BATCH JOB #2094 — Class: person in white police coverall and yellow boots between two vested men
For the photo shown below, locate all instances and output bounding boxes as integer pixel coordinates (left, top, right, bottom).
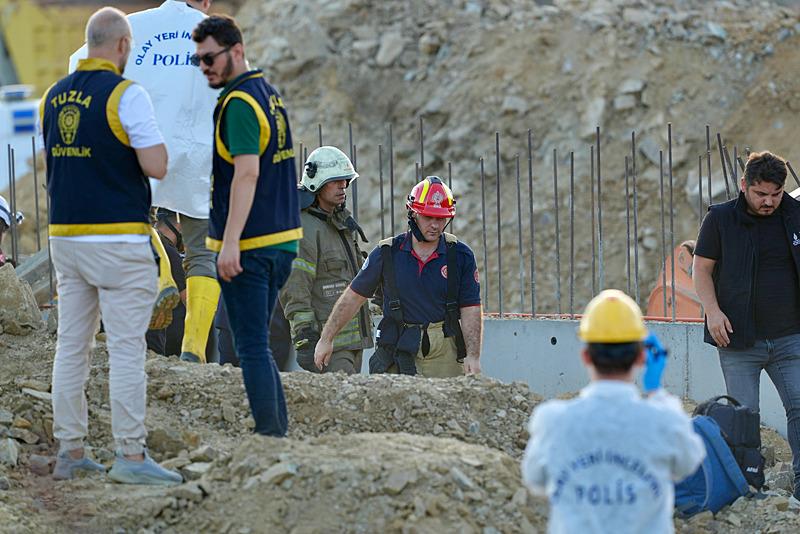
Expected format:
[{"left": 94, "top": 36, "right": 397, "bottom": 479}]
[{"left": 70, "top": 0, "right": 219, "bottom": 362}]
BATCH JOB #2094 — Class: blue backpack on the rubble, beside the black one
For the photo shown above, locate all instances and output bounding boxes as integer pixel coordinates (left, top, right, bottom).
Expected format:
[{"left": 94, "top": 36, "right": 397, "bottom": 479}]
[{"left": 675, "top": 415, "right": 750, "bottom": 518}]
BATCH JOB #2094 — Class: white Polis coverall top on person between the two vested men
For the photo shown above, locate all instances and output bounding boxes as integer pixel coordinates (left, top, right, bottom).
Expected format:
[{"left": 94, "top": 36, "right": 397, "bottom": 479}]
[{"left": 69, "top": 0, "right": 218, "bottom": 219}]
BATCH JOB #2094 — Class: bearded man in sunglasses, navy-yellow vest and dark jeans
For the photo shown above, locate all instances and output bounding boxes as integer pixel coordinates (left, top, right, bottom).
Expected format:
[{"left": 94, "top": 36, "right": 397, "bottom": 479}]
[{"left": 192, "top": 15, "right": 303, "bottom": 436}]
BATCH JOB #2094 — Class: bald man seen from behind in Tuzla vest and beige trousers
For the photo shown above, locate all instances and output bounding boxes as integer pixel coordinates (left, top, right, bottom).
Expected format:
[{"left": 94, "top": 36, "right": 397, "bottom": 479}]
[{"left": 40, "top": 7, "right": 182, "bottom": 485}]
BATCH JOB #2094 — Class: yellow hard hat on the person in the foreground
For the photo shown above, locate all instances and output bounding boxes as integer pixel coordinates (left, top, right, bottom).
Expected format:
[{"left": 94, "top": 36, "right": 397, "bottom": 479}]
[{"left": 578, "top": 289, "right": 647, "bottom": 343}]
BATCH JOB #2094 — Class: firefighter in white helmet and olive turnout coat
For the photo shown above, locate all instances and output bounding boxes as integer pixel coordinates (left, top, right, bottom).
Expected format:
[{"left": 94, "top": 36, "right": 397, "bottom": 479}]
[{"left": 280, "top": 146, "right": 372, "bottom": 374}]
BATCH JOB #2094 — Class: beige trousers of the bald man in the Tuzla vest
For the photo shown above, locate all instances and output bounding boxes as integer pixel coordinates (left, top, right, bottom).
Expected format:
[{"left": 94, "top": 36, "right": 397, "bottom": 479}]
[{"left": 50, "top": 239, "right": 157, "bottom": 455}]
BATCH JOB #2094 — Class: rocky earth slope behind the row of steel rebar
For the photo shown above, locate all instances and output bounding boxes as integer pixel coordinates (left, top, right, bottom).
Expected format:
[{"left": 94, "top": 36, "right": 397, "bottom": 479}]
[{"left": 228, "top": 0, "right": 800, "bottom": 312}]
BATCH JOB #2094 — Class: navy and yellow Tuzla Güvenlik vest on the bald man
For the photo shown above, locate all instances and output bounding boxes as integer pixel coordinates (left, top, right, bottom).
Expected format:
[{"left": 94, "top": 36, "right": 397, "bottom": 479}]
[{"left": 40, "top": 58, "right": 150, "bottom": 236}]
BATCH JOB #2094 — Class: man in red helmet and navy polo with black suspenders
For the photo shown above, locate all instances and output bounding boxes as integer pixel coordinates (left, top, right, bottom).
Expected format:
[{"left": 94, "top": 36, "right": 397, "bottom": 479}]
[{"left": 314, "top": 176, "right": 483, "bottom": 377}]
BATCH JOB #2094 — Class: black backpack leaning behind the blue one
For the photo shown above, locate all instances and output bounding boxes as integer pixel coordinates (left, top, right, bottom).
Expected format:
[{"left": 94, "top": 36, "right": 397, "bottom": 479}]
[{"left": 694, "top": 395, "right": 765, "bottom": 490}]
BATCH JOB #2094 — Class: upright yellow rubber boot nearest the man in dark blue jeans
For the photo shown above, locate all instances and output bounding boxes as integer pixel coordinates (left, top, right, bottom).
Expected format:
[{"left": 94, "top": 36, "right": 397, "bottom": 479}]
[{"left": 181, "top": 276, "right": 220, "bottom": 363}]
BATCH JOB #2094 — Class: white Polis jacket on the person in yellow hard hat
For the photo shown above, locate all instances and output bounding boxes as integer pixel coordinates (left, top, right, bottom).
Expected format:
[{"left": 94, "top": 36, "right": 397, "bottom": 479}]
[{"left": 522, "top": 380, "right": 705, "bottom": 534}]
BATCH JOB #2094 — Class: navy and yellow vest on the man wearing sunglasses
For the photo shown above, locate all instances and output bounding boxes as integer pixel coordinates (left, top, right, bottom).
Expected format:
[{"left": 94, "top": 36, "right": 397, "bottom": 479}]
[{"left": 206, "top": 70, "right": 303, "bottom": 252}]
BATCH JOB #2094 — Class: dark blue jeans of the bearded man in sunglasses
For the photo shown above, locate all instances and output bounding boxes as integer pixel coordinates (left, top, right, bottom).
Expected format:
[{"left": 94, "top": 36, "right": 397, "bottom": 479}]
[{"left": 220, "top": 248, "right": 295, "bottom": 436}]
